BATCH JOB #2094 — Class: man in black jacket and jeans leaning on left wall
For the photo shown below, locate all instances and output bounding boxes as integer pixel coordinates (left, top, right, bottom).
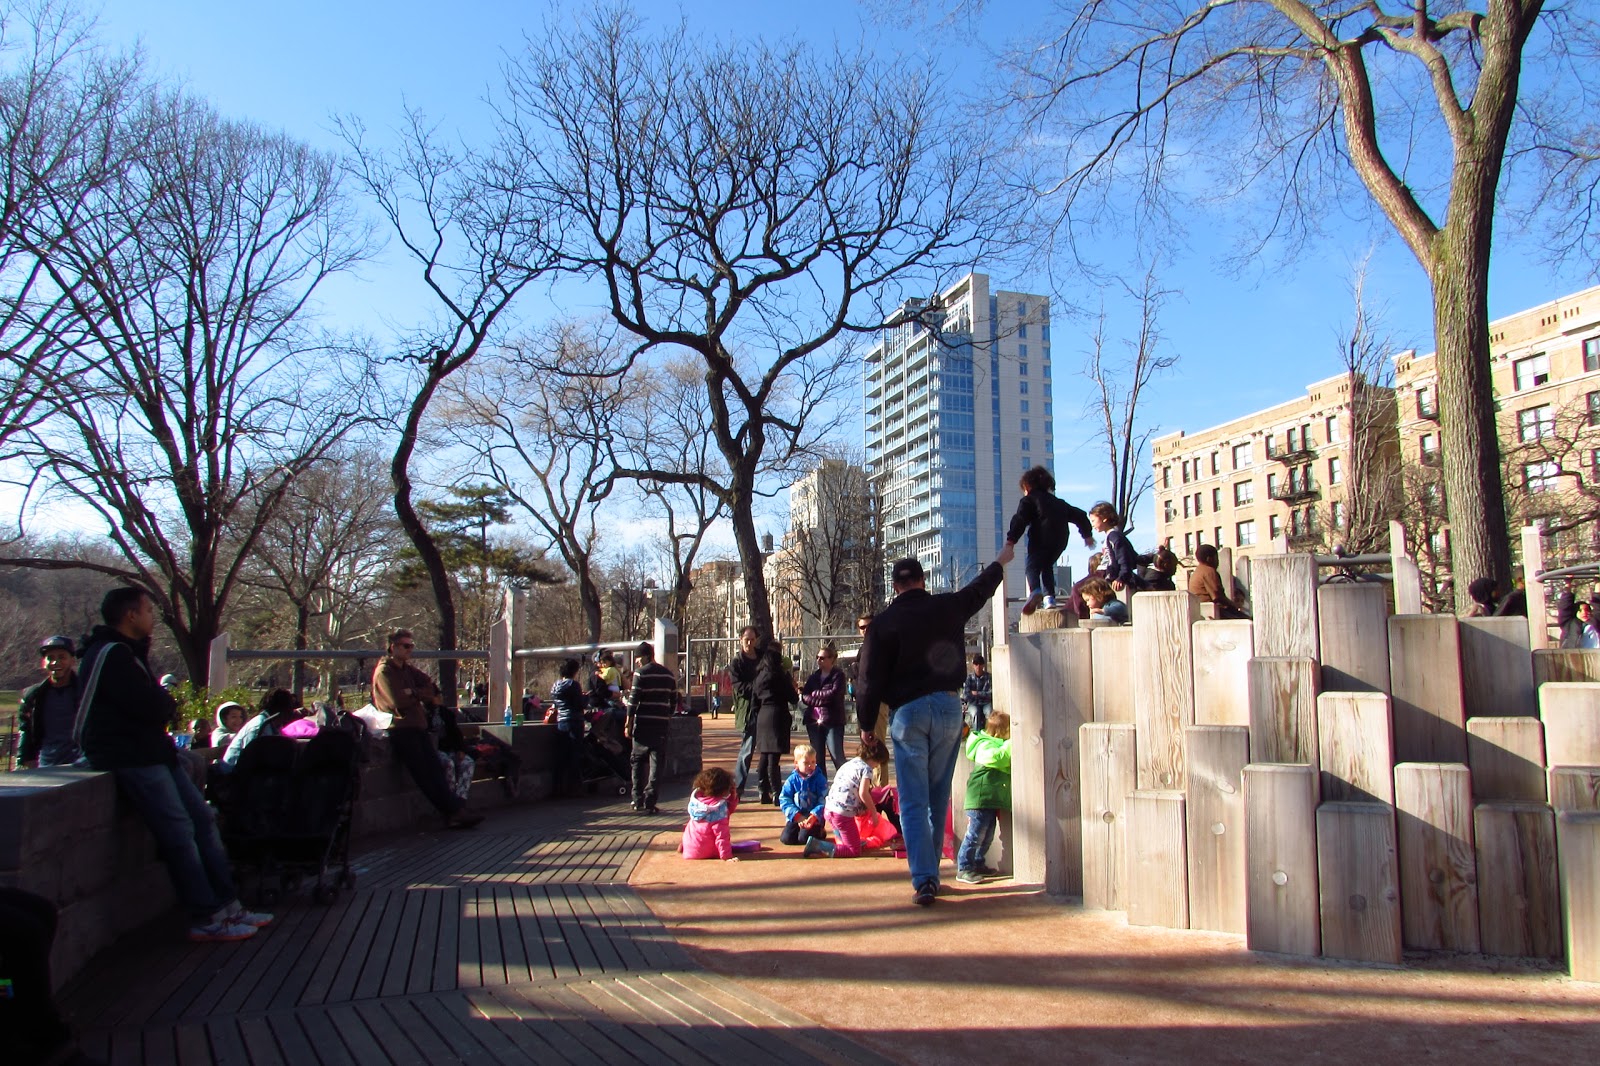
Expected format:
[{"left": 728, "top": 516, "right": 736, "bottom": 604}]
[{"left": 77, "top": 587, "right": 272, "bottom": 941}]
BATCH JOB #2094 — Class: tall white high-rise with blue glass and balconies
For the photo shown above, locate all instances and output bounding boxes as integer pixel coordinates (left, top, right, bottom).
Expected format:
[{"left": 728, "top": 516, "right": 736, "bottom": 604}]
[{"left": 866, "top": 274, "right": 1056, "bottom": 595}]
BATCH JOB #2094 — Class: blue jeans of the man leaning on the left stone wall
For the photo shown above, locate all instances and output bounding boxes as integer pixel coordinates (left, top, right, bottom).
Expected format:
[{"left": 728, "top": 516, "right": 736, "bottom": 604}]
[{"left": 112, "top": 763, "right": 238, "bottom": 920}]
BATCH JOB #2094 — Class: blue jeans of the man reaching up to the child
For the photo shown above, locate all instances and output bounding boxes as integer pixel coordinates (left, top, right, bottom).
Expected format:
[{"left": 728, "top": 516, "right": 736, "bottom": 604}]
[{"left": 890, "top": 691, "right": 962, "bottom": 888}]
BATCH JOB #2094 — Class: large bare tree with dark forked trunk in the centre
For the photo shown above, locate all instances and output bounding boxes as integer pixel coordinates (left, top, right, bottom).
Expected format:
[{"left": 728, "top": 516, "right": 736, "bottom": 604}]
[{"left": 502, "top": 11, "right": 1011, "bottom": 629}]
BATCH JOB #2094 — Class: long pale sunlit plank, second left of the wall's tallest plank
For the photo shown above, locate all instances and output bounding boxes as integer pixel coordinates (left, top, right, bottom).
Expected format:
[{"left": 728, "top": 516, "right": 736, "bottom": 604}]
[{"left": 1133, "top": 592, "right": 1200, "bottom": 789}]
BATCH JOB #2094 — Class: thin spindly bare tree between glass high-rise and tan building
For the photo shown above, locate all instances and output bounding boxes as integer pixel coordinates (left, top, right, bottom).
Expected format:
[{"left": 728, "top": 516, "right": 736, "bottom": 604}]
[{"left": 1083, "top": 262, "right": 1178, "bottom": 530}]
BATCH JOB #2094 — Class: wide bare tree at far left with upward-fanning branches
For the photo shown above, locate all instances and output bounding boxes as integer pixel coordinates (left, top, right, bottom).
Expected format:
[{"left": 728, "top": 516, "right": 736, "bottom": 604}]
[{"left": 3, "top": 90, "right": 366, "bottom": 683}]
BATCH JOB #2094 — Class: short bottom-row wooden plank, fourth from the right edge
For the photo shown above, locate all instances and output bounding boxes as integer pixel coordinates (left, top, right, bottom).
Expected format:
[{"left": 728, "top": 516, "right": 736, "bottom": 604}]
[{"left": 1317, "top": 802, "right": 1403, "bottom": 965}]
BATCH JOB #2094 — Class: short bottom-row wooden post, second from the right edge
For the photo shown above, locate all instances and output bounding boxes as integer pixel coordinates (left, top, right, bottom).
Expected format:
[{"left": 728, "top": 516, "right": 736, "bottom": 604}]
[{"left": 1474, "top": 802, "right": 1562, "bottom": 959}]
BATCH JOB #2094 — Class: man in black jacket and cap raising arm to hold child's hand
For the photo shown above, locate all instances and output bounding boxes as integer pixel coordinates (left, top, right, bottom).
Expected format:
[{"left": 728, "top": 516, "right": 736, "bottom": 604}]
[{"left": 856, "top": 543, "right": 1014, "bottom": 906}]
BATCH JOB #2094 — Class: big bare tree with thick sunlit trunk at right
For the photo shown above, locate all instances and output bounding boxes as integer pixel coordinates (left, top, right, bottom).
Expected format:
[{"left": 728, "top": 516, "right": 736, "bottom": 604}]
[{"left": 1011, "top": 0, "right": 1592, "bottom": 607}]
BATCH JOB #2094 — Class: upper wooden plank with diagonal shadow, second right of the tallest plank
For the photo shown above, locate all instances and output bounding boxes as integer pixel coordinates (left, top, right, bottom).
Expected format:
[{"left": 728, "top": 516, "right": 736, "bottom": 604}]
[{"left": 1389, "top": 615, "right": 1467, "bottom": 762}]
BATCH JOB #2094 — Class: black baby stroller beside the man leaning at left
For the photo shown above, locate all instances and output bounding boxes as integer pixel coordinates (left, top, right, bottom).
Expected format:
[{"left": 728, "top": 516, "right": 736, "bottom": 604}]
[{"left": 213, "top": 728, "right": 360, "bottom": 906}]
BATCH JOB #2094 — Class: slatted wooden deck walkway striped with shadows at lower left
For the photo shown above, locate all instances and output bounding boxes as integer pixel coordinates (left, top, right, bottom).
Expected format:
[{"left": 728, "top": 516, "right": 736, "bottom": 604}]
[{"left": 62, "top": 800, "right": 883, "bottom": 1066}]
